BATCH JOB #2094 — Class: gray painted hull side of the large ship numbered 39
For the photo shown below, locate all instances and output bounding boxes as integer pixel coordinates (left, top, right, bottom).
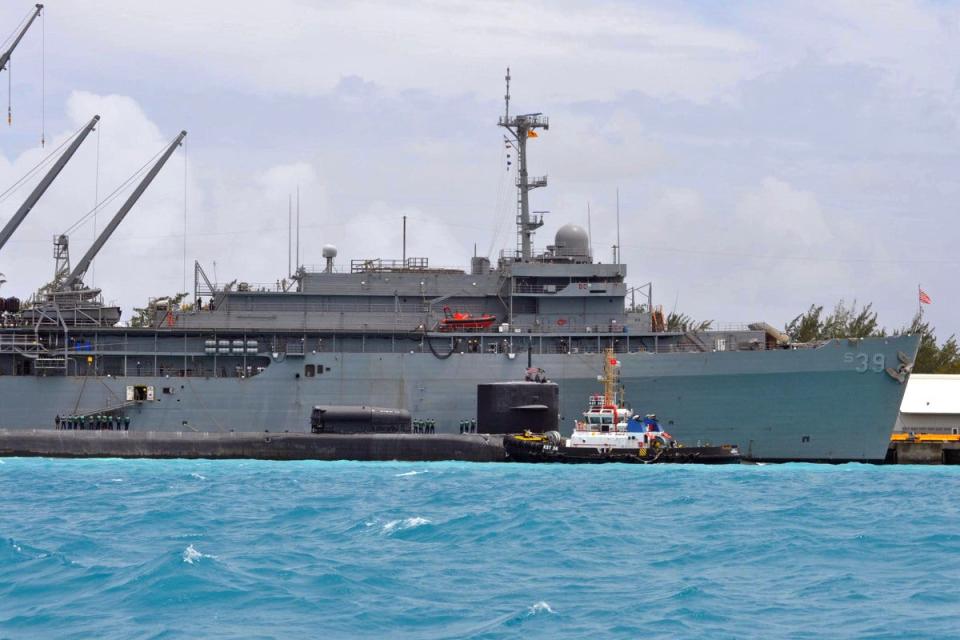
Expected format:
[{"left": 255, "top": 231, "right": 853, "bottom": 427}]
[{"left": 0, "top": 336, "right": 918, "bottom": 462}]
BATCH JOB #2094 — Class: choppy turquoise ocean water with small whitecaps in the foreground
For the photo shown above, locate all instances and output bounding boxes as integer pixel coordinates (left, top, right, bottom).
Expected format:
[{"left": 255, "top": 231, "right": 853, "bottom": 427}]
[{"left": 0, "top": 458, "right": 960, "bottom": 638}]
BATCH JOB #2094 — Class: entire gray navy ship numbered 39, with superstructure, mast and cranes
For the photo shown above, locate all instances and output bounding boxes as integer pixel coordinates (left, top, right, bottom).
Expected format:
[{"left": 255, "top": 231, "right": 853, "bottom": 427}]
[{"left": 0, "top": 71, "right": 919, "bottom": 462}]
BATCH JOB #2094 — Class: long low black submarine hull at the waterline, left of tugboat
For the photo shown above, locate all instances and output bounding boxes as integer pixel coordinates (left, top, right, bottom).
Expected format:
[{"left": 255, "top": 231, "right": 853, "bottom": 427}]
[{"left": 0, "top": 429, "right": 505, "bottom": 462}]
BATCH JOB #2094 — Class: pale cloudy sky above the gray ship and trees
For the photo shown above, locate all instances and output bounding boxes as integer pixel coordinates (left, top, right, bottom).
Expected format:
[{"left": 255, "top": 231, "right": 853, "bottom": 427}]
[{"left": 0, "top": 0, "right": 960, "bottom": 340}]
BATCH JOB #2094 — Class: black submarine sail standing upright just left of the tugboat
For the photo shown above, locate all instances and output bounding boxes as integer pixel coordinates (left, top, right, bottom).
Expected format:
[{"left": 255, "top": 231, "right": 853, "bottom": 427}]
[{"left": 477, "top": 382, "right": 560, "bottom": 433}]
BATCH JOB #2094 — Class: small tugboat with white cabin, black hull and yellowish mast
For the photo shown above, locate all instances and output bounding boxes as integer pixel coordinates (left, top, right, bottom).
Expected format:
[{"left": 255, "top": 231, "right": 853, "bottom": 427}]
[{"left": 503, "top": 349, "right": 740, "bottom": 464}]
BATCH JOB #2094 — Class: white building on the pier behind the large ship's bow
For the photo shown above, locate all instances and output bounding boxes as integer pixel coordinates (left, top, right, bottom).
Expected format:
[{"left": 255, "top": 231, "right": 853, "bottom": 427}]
[{"left": 894, "top": 373, "right": 960, "bottom": 435}]
